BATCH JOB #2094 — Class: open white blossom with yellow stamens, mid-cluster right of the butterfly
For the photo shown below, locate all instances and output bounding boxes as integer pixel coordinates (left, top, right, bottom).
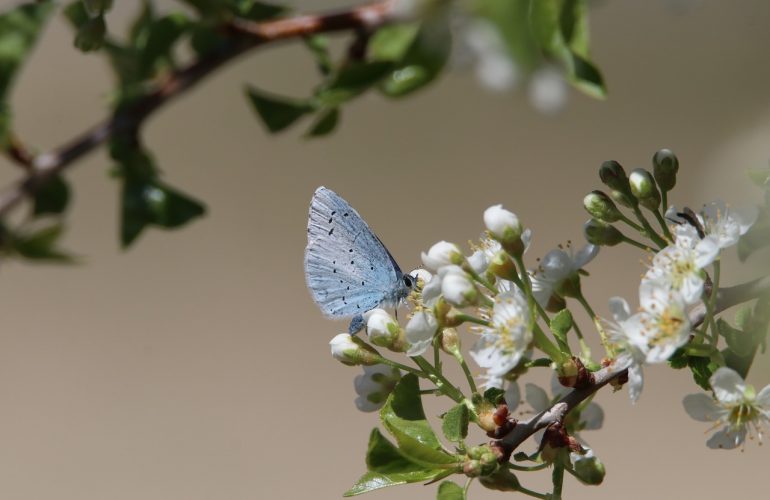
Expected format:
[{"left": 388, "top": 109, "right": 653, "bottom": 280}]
[{"left": 470, "top": 288, "right": 532, "bottom": 377}]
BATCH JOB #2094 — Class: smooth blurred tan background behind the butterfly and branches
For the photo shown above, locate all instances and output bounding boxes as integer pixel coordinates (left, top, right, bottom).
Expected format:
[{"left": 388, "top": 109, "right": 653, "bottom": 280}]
[{"left": 0, "top": 0, "right": 770, "bottom": 500}]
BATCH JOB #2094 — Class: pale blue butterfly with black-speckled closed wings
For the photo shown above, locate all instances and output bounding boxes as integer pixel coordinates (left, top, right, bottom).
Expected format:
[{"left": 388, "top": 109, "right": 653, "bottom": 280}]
[{"left": 305, "top": 186, "right": 416, "bottom": 334}]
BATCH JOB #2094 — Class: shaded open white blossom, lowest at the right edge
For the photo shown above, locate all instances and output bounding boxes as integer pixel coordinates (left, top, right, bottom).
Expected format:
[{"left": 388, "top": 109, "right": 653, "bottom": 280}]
[{"left": 683, "top": 367, "right": 770, "bottom": 449}]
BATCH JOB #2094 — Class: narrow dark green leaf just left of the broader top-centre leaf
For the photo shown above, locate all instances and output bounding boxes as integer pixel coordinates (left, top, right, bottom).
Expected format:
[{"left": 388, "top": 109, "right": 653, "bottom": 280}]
[{"left": 316, "top": 61, "right": 393, "bottom": 107}]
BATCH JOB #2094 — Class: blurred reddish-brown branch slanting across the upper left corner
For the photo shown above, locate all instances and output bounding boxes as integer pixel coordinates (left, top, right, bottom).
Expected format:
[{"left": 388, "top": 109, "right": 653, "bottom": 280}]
[{"left": 0, "top": 0, "right": 400, "bottom": 216}]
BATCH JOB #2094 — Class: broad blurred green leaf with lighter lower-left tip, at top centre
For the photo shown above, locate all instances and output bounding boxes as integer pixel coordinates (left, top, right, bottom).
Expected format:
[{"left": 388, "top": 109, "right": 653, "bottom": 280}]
[{"left": 380, "top": 8, "right": 452, "bottom": 97}]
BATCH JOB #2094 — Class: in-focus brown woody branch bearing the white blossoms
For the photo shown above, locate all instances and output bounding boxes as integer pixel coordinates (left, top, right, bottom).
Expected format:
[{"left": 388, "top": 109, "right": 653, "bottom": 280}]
[{"left": 496, "top": 276, "right": 770, "bottom": 457}]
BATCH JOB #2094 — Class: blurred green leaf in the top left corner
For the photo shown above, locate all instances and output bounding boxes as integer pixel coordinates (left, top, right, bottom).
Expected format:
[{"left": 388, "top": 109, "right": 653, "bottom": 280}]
[{"left": 0, "top": 1, "right": 54, "bottom": 149}]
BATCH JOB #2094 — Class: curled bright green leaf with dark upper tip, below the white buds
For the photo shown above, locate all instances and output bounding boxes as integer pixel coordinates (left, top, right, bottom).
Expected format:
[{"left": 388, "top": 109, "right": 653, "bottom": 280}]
[{"left": 380, "top": 374, "right": 457, "bottom": 468}]
